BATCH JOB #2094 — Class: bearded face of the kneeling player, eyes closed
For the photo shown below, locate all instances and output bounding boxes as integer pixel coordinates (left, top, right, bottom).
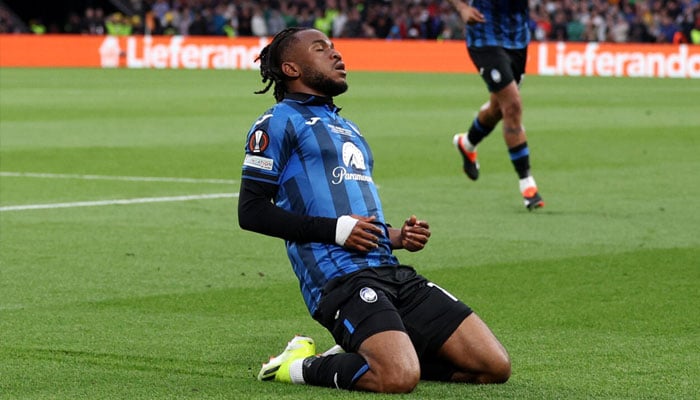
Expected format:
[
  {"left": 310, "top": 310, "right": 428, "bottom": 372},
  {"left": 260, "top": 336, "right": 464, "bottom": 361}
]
[{"left": 297, "top": 30, "right": 348, "bottom": 97}]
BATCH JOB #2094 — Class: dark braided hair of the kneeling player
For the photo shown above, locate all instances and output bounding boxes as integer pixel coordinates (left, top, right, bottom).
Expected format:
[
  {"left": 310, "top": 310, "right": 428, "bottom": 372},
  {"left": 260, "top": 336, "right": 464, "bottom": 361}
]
[{"left": 255, "top": 26, "right": 310, "bottom": 102}]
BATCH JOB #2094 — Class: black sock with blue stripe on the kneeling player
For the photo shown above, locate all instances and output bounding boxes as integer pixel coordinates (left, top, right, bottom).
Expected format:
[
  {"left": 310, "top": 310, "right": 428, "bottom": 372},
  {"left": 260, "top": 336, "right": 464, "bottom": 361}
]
[{"left": 302, "top": 353, "right": 369, "bottom": 389}]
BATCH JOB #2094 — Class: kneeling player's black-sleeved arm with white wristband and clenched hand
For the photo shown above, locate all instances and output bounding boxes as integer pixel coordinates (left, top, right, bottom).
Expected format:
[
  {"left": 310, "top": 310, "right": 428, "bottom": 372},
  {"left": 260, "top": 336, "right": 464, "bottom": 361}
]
[{"left": 238, "top": 178, "right": 382, "bottom": 252}]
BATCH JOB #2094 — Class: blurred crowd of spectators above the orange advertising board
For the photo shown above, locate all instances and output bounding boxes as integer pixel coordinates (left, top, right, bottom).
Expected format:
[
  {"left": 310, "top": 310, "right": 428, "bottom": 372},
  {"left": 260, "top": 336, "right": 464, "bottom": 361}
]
[{"left": 0, "top": 0, "right": 700, "bottom": 44}]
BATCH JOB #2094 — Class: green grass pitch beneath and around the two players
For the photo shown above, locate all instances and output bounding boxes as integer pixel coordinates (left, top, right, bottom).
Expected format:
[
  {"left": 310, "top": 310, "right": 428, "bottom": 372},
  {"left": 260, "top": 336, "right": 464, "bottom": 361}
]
[{"left": 0, "top": 69, "right": 700, "bottom": 399}]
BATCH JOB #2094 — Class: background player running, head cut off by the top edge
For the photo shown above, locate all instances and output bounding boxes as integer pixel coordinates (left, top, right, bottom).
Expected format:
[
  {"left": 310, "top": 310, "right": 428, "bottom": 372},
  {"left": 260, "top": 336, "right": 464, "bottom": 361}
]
[{"left": 448, "top": 0, "right": 544, "bottom": 210}]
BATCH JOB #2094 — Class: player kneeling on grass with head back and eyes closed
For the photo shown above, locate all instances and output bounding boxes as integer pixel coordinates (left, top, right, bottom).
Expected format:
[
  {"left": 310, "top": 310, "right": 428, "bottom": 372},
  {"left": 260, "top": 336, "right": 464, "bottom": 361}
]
[{"left": 238, "top": 28, "right": 511, "bottom": 393}]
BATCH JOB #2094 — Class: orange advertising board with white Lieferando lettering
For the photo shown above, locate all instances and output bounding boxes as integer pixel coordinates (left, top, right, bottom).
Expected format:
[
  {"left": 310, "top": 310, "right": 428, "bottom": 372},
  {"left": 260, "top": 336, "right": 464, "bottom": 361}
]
[{"left": 0, "top": 35, "right": 700, "bottom": 78}]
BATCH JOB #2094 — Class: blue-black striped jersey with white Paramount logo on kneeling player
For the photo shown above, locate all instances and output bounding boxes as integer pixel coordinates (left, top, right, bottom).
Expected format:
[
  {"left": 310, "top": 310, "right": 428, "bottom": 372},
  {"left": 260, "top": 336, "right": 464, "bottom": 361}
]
[{"left": 242, "top": 96, "right": 398, "bottom": 315}]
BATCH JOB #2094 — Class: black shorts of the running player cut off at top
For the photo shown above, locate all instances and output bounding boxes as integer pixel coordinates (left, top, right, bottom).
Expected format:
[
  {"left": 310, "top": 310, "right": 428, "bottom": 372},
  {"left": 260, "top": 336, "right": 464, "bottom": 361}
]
[{"left": 467, "top": 47, "right": 527, "bottom": 93}]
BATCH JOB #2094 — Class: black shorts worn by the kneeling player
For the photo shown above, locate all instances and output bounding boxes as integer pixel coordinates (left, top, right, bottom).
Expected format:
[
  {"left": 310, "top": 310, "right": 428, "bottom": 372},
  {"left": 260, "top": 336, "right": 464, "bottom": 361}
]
[{"left": 314, "top": 266, "right": 472, "bottom": 358}]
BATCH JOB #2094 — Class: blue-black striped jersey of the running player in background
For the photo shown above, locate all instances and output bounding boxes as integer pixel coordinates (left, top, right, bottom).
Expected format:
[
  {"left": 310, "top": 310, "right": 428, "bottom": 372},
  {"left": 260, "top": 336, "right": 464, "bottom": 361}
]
[{"left": 467, "top": 0, "right": 530, "bottom": 49}]
